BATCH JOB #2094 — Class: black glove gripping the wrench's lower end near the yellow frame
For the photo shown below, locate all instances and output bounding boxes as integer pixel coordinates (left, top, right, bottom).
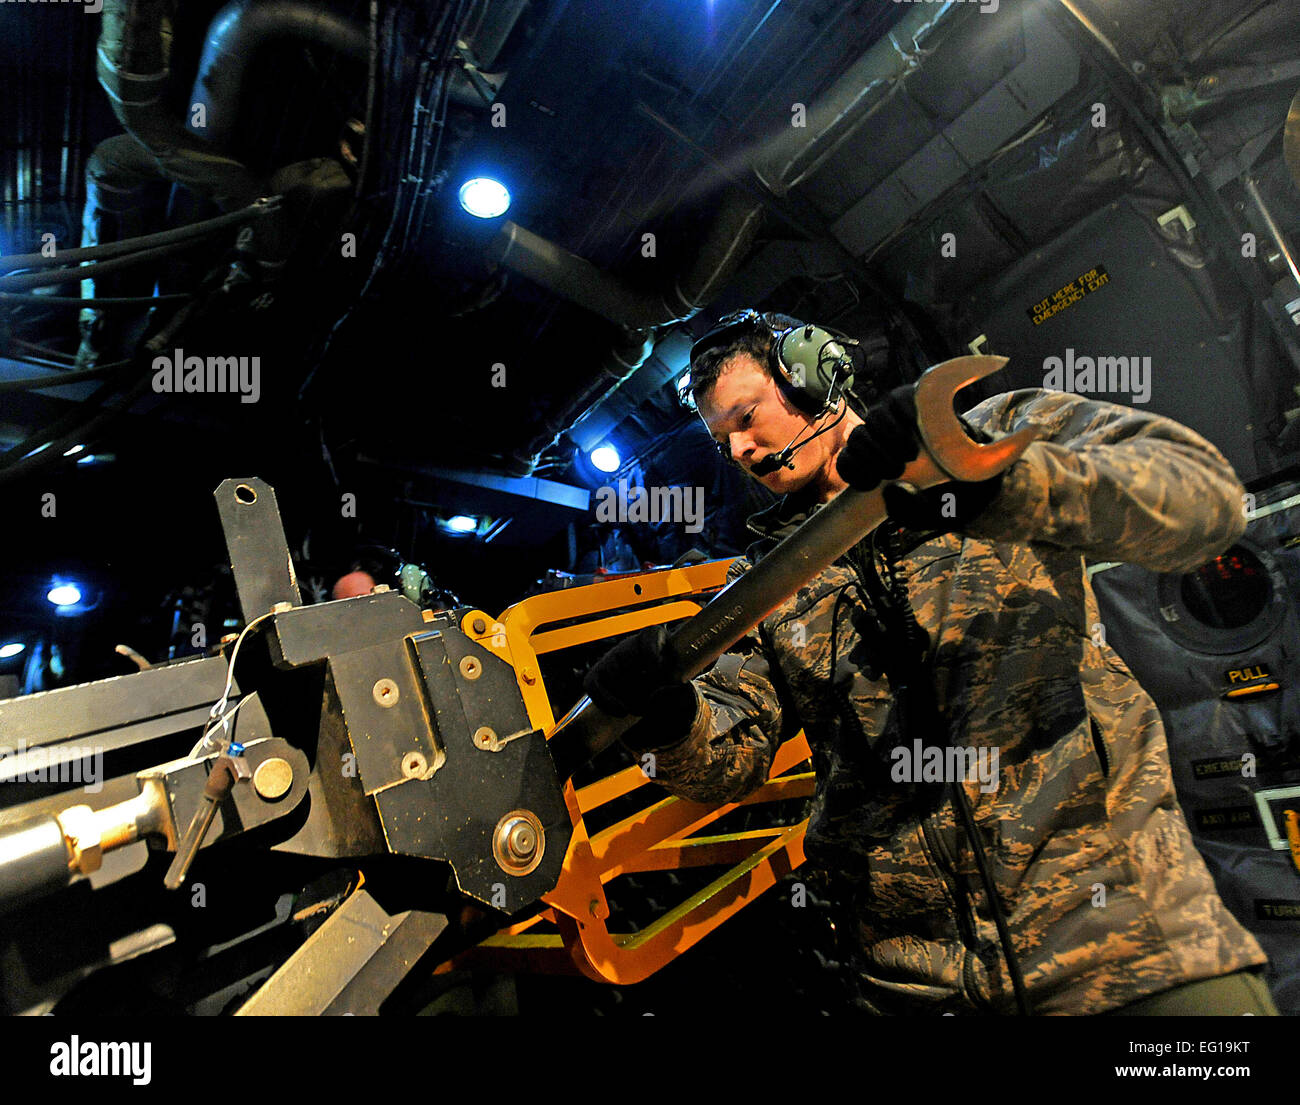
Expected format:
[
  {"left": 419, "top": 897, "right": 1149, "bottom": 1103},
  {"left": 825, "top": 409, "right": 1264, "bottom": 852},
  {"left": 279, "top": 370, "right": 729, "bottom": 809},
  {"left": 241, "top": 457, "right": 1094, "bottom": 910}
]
[{"left": 582, "top": 625, "right": 697, "bottom": 751}]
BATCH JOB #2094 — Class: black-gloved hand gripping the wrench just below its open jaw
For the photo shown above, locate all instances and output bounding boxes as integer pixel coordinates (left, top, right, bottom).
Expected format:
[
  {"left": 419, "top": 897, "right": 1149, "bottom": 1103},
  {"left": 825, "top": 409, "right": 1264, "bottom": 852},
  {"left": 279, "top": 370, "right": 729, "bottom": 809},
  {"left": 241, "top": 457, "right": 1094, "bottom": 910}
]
[{"left": 836, "top": 385, "right": 1005, "bottom": 533}]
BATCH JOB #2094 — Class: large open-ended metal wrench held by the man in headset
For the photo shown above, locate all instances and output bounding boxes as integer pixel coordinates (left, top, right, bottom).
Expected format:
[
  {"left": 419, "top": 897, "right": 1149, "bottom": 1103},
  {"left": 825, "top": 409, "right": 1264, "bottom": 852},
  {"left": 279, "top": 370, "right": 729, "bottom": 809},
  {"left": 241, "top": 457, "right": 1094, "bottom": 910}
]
[{"left": 546, "top": 356, "right": 1043, "bottom": 779}]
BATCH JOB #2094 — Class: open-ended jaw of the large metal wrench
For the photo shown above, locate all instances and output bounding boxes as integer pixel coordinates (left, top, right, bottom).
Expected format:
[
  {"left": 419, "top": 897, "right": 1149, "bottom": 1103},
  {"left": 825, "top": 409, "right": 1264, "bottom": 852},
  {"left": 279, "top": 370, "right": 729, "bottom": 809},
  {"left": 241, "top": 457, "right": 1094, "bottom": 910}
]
[{"left": 915, "top": 354, "right": 1043, "bottom": 482}]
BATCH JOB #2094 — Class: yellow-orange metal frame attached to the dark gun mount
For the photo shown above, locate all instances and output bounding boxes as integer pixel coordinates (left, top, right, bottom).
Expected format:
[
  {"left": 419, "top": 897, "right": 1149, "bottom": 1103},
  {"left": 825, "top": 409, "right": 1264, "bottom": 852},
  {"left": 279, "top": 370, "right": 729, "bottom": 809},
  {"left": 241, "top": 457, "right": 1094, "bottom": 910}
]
[{"left": 445, "top": 560, "right": 814, "bottom": 984}]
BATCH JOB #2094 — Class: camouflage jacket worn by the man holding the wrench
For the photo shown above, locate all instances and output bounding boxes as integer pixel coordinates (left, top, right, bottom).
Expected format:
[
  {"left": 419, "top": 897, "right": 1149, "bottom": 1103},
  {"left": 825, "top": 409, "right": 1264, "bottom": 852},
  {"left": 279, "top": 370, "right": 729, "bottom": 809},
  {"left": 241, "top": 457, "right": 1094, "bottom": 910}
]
[{"left": 657, "top": 389, "right": 1265, "bottom": 1014}]
